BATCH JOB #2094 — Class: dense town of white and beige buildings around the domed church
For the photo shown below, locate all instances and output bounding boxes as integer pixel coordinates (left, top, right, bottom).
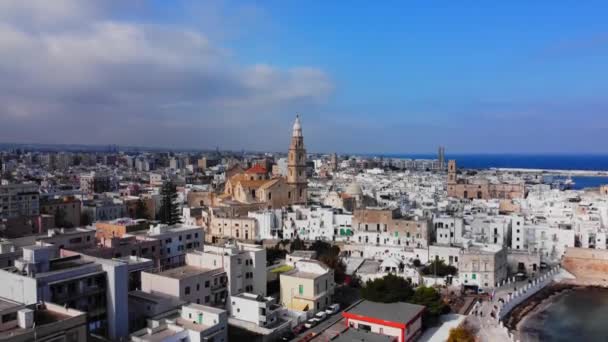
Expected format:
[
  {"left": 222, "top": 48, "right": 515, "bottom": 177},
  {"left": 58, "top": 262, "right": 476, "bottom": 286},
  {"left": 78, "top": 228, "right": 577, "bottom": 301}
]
[{"left": 0, "top": 117, "right": 608, "bottom": 342}]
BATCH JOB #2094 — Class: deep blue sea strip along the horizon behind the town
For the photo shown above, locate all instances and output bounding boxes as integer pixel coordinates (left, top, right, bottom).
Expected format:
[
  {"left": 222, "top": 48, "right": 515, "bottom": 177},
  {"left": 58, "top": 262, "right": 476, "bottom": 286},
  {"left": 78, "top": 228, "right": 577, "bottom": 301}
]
[{"left": 379, "top": 154, "right": 608, "bottom": 190}]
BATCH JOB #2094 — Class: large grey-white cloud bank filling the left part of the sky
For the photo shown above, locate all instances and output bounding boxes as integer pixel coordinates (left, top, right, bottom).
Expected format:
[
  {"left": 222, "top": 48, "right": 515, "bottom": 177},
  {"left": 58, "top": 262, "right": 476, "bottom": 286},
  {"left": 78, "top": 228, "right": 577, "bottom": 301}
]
[{"left": 0, "top": 0, "right": 333, "bottom": 148}]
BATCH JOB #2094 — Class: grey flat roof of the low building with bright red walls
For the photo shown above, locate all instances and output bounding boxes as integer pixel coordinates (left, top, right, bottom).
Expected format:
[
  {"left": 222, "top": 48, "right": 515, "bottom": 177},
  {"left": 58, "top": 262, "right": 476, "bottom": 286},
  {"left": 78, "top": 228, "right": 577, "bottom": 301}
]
[{"left": 345, "top": 300, "right": 424, "bottom": 324}]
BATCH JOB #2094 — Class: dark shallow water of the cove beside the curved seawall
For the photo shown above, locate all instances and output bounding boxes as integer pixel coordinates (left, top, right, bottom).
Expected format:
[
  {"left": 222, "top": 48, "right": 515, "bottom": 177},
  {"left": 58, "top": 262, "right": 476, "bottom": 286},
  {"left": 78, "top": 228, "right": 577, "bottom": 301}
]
[{"left": 520, "top": 288, "right": 608, "bottom": 342}]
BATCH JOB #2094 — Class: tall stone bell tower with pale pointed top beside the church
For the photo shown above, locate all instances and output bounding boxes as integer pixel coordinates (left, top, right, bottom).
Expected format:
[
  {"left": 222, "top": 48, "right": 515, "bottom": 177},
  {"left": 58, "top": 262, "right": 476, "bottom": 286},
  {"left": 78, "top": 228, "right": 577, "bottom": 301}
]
[{"left": 287, "top": 114, "right": 308, "bottom": 204}]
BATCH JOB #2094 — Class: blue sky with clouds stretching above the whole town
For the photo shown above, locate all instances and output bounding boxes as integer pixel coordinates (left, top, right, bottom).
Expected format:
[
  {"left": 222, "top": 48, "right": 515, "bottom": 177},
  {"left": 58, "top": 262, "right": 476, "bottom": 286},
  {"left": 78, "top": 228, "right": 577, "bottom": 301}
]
[{"left": 0, "top": 0, "right": 608, "bottom": 153}]
